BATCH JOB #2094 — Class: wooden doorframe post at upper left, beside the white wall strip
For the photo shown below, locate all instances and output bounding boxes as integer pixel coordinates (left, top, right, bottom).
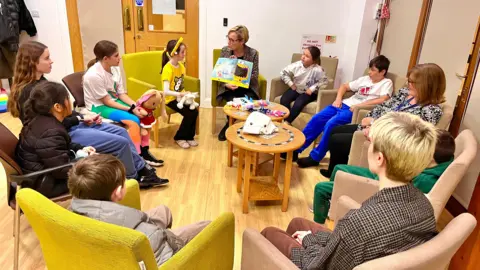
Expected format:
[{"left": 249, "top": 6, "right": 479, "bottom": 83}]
[{"left": 65, "top": 0, "right": 85, "bottom": 72}]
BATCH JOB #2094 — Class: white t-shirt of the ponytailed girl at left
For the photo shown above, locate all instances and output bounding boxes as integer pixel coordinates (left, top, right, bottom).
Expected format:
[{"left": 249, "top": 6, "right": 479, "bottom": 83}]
[{"left": 83, "top": 62, "right": 126, "bottom": 110}]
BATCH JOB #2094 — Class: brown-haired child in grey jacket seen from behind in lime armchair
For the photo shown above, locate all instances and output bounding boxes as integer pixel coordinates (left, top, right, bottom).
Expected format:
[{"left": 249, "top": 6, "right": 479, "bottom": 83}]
[{"left": 68, "top": 154, "right": 210, "bottom": 266}]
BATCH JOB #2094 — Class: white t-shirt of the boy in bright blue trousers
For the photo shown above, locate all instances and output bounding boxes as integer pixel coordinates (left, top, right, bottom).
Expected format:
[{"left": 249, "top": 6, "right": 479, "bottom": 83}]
[{"left": 342, "top": 76, "right": 393, "bottom": 107}]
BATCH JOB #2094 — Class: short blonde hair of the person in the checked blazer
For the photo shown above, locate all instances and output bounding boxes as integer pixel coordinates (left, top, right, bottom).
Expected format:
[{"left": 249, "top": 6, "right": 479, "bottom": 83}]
[{"left": 369, "top": 112, "right": 437, "bottom": 182}]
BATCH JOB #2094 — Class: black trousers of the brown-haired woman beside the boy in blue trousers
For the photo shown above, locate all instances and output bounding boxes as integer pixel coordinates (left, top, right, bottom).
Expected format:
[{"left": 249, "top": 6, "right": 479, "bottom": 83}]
[{"left": 328, "top": 124, "right": 358, "bottom": 174}]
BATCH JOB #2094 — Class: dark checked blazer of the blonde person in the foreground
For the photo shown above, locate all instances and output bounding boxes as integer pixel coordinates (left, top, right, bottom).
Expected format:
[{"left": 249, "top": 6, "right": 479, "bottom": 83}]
[{"left": 291, "top": 184, "right": 437, "bottom": 270}]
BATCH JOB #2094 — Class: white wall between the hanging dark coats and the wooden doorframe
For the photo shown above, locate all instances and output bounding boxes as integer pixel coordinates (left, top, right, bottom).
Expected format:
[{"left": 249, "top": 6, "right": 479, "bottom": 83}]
[{"left": 21, "top": 0, "right": 73, "bottom": 82}]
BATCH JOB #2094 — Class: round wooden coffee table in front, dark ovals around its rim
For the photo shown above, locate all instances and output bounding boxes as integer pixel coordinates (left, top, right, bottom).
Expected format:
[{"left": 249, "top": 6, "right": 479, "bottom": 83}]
[{"left": 226, "top": 122, "right": 305, "bottom": 213}]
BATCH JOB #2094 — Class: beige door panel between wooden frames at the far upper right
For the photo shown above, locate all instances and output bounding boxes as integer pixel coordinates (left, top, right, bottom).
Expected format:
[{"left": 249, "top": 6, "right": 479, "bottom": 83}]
[{"left": 419, "top": 0, "right": 480, "bottom": 106}]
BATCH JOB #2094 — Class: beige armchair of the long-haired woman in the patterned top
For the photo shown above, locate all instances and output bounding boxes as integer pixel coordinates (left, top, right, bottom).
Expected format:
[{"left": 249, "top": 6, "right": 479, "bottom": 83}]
[{"left": 348, "top": 103, "right": 453, "bottom": 167}]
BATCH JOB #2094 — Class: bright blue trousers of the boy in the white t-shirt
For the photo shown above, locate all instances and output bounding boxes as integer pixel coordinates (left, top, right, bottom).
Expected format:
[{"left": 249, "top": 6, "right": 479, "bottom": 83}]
[{"left": 297, "top": 103, "right": 353, "bottom": 162}]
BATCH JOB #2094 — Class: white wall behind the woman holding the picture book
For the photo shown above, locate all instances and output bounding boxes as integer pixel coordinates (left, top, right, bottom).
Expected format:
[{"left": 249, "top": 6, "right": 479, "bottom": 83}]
[{"left": 199, "top": 0, "right": 379, "bottom": 107}]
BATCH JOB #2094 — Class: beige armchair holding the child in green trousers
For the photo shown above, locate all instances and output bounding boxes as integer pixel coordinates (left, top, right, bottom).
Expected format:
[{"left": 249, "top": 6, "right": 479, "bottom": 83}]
[{"left": 329, "top": 129, "right": 477, "bottom": 220}]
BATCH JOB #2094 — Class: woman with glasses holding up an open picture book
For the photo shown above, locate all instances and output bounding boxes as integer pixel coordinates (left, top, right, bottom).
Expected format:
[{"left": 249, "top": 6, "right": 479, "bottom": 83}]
[{"left": 216, "top": 25, "right": 259, "bottom": 141}]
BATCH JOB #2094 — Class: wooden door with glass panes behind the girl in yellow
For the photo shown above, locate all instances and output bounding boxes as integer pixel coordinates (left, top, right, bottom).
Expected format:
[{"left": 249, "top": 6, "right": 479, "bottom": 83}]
[{"left": 122, "top": 0, "right": 199, "bottom": 78}]
